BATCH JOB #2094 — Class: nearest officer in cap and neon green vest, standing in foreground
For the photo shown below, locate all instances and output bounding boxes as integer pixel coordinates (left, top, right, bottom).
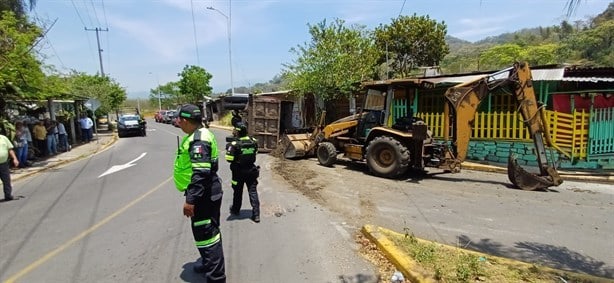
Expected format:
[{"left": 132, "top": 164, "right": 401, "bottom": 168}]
[{"left": 173, "top": 104, "right": 226, "bottom": 282}]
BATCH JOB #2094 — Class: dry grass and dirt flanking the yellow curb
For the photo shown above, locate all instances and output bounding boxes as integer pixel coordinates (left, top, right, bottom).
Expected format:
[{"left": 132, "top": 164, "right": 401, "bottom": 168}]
[{"left": 358, "top": 229, "right": 614, "bottom": 283}]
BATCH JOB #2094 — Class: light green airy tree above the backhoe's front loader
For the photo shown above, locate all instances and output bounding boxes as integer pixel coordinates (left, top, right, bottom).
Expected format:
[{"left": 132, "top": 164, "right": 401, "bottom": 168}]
[{"left": 283, "top": 19, "right": 378, "bottom": 101}]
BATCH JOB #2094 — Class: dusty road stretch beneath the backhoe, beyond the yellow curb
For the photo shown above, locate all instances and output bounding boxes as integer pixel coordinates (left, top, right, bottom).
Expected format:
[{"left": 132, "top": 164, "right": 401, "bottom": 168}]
[{"left": 276, "top": 154, "right": 614, "bottom": 278}]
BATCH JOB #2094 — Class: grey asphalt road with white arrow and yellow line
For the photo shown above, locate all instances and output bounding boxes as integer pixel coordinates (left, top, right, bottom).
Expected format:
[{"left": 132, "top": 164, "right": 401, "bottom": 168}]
[{"left": 0, "top": 122, "right": 377, "bottom": 282}]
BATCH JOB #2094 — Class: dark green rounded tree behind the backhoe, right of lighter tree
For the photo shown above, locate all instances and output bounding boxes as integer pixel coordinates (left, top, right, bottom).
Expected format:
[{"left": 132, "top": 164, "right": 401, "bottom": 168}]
[{"left": 375, "top": 14, "right": 450, "bottom": 77}]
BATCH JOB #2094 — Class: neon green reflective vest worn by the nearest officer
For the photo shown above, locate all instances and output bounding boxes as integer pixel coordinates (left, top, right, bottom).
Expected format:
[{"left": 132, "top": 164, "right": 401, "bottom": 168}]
[{"left": 173, "top": 128, "right": 218, "bottom": 192}]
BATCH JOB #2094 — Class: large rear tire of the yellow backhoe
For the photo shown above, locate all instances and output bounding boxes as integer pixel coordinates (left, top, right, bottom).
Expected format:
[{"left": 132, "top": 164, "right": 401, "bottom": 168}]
[{"left": 367, "top": 136, "right": 409, "bottom": 178}]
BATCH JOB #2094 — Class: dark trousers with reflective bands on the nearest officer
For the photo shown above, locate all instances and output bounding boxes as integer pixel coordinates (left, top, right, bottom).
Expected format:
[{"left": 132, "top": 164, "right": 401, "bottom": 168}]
[{"left": 190, "top": 195, "right": 226, "bottom": 283}]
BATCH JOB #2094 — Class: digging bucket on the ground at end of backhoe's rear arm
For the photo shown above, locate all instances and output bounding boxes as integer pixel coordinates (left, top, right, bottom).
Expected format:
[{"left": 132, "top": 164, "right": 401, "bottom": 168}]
[{"left": 507, "top": 154, "right": 563, "bottom": 191}]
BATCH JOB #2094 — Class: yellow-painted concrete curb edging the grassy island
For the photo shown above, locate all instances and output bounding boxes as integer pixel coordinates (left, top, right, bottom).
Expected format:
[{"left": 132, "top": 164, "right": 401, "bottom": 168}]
[{"left": 361, "top": 224, "right": 614, "bottom": 283}]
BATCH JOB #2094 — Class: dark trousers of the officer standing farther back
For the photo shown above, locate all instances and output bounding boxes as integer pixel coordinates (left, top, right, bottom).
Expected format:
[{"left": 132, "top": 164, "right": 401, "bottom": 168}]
[{"left": 230, "top": 166, "right": 260, "bottom": 216}]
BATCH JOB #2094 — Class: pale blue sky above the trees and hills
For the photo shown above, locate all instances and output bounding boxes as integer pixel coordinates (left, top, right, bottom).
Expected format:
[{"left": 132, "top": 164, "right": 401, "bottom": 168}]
[{"left": 31, "top": 0, "right": 611, "bottom": 98}]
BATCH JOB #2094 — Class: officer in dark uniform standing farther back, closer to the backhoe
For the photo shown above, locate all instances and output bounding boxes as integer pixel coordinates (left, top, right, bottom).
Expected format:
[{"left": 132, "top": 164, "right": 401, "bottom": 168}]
[{"left": 226, "top": 122, "right": 260, "bottom": 223}]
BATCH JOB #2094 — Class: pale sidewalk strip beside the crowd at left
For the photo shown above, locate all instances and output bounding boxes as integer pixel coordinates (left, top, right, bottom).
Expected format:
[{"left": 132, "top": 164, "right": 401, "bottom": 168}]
[{"left": 11, "top": 131, "right": 117, "bottom": 182}]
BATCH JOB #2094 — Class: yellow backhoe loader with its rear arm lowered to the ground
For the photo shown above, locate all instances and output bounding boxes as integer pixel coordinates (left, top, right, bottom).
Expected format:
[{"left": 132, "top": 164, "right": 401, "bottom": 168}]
[{"left": 282, "top": 63, "right": 562, "bottom": 190}]
